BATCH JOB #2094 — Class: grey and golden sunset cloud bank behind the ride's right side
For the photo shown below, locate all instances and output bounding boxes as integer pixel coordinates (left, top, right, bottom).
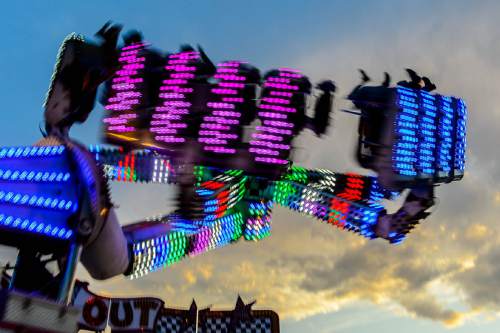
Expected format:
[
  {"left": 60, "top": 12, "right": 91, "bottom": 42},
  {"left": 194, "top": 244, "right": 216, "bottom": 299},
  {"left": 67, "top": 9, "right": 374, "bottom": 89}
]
[{"left": 76, "top": 2, "right": 500, "bottom": 326}]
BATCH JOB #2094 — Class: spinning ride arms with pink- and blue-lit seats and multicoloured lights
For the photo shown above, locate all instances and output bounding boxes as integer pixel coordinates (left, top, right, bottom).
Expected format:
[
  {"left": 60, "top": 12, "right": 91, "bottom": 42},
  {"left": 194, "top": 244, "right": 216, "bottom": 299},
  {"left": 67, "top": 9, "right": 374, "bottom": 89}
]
[{"left": 0, "top": 25, "right": 466, "bottom": 279}]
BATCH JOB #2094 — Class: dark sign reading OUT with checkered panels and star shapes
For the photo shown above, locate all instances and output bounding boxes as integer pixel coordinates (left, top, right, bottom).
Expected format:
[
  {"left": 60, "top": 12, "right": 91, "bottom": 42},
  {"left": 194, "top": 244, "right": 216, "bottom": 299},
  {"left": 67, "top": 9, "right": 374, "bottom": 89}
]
[{"left": 73, "top": 282, "right": 279, "bottom": 333}]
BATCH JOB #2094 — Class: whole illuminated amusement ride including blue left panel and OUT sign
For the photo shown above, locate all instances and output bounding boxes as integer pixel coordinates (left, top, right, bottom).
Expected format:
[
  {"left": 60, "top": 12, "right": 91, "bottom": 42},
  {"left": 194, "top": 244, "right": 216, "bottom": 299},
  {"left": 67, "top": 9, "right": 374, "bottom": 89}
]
[{"left": 0, "top": 24, "right": 467, "bottom": 332}]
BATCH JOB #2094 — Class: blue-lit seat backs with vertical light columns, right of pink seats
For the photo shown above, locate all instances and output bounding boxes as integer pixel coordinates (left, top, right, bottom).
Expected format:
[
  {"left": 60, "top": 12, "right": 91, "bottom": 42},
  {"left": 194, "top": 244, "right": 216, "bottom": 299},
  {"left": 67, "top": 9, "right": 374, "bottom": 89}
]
[{"left": 392, "top": 86, "right": 466, "bottom": 182}]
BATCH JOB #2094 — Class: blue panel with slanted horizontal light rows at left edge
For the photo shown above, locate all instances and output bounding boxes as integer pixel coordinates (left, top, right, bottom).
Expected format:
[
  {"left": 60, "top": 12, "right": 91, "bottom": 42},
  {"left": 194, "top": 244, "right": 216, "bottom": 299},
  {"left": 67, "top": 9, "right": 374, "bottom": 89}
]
[{"left": 0, "top": 146, "right": 78, "bottom": 241}]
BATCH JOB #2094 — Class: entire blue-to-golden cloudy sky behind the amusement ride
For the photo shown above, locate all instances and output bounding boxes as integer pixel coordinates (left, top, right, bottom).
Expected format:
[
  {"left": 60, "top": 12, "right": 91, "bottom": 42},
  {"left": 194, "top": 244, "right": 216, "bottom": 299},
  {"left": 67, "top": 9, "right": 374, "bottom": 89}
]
[{"left": 0, "top": 0, "right": 500, "bottom": 333}]
